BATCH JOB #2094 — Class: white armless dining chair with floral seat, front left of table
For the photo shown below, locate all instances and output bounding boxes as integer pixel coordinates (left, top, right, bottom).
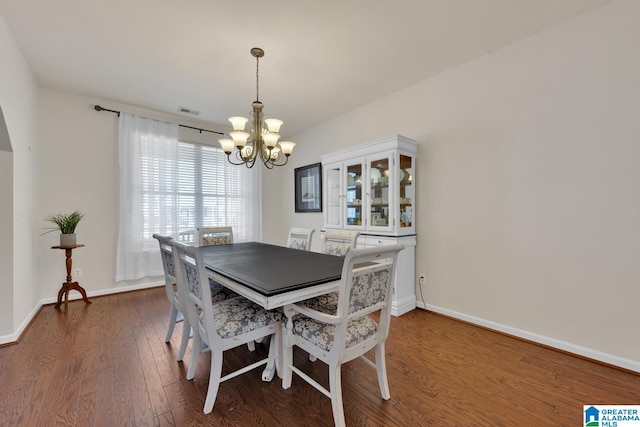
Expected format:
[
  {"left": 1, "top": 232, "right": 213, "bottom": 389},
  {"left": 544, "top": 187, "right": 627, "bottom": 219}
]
[{"left": 173, "top": 242, "right": 282, "bottom": 414}]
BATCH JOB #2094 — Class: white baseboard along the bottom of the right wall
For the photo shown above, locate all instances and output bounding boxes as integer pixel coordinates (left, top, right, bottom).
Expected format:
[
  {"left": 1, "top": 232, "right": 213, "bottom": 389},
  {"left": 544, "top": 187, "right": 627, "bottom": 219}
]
[{"left": 417, "top": 301, "right": 640, "bottom": 373}]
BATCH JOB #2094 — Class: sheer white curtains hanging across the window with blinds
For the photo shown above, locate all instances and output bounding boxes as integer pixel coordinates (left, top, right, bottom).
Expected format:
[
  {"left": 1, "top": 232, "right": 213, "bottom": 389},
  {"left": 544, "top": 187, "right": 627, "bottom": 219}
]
[{"left": 116, "top": 112, "right": 262, "bottom": 281}]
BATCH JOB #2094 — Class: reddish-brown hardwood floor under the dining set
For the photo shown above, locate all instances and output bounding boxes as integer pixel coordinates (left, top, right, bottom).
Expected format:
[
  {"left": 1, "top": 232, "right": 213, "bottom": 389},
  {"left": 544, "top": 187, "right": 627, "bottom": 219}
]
[{"left": 0, "top": 288, "right": 640, "bottom": 427}]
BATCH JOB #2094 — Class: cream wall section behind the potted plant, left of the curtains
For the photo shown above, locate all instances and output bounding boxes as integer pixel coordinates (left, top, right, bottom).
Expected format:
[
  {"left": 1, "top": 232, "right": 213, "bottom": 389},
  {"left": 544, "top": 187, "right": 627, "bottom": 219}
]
[{"left": 38, "top": 90, "right": 118, "bottom": 298}]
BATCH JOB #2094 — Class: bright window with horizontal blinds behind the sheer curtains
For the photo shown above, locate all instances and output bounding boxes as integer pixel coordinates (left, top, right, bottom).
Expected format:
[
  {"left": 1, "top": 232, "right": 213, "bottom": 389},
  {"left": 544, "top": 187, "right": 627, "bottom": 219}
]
[{"left": 141, "top": 137, "right": 250, "bottom": 245}]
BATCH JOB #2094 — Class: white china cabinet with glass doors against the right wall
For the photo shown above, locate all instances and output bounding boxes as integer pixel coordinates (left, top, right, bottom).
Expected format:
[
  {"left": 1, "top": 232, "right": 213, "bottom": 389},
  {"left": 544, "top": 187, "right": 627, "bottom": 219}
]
[{"left": 322, "top": 135, "right": 416, "bottom": 316}]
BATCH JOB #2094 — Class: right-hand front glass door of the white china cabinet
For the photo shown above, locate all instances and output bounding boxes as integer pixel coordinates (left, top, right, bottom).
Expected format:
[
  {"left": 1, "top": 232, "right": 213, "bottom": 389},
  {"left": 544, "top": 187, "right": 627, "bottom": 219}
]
[{"left": 367, "top": 156, "right": 393, "bottom": 230}]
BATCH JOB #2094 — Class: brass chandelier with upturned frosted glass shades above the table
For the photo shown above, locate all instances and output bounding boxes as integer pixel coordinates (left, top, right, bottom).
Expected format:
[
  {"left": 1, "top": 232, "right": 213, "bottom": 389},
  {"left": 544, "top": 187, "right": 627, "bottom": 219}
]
[{"left": 218, "top": 47, "right": 296, "bottom": 169}]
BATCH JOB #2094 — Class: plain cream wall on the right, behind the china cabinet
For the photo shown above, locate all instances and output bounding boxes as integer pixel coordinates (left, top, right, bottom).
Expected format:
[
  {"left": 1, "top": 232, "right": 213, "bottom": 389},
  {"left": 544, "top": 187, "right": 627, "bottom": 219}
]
[{"left": 265, "top": 0, "right": 640, "bottom": 371}]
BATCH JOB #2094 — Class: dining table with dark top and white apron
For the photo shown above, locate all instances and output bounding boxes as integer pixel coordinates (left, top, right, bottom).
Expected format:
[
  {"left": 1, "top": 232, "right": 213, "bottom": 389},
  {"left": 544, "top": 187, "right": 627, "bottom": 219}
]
[{"left": 200, "top": 242, "right": 344, "bottom": 381}]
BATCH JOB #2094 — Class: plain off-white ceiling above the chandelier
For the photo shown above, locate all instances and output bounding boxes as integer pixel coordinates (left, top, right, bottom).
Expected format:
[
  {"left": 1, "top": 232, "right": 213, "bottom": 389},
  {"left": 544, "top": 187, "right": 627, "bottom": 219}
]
[{"left": 0, "top": 0, "right": 609, "bottom": 136}]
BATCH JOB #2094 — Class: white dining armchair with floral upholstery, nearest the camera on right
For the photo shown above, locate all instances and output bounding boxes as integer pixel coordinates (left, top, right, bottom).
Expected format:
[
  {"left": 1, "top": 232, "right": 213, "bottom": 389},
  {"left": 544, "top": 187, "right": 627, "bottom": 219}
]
[{"left": 282, "top": 245, "right": 404, "bottom": 427}]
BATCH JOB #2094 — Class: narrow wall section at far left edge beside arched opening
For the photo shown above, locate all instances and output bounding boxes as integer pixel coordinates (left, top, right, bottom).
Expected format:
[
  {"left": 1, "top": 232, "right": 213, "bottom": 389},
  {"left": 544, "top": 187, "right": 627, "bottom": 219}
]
[{"left": 0, "top": 15, "right": 38, "bottom": 341}]
